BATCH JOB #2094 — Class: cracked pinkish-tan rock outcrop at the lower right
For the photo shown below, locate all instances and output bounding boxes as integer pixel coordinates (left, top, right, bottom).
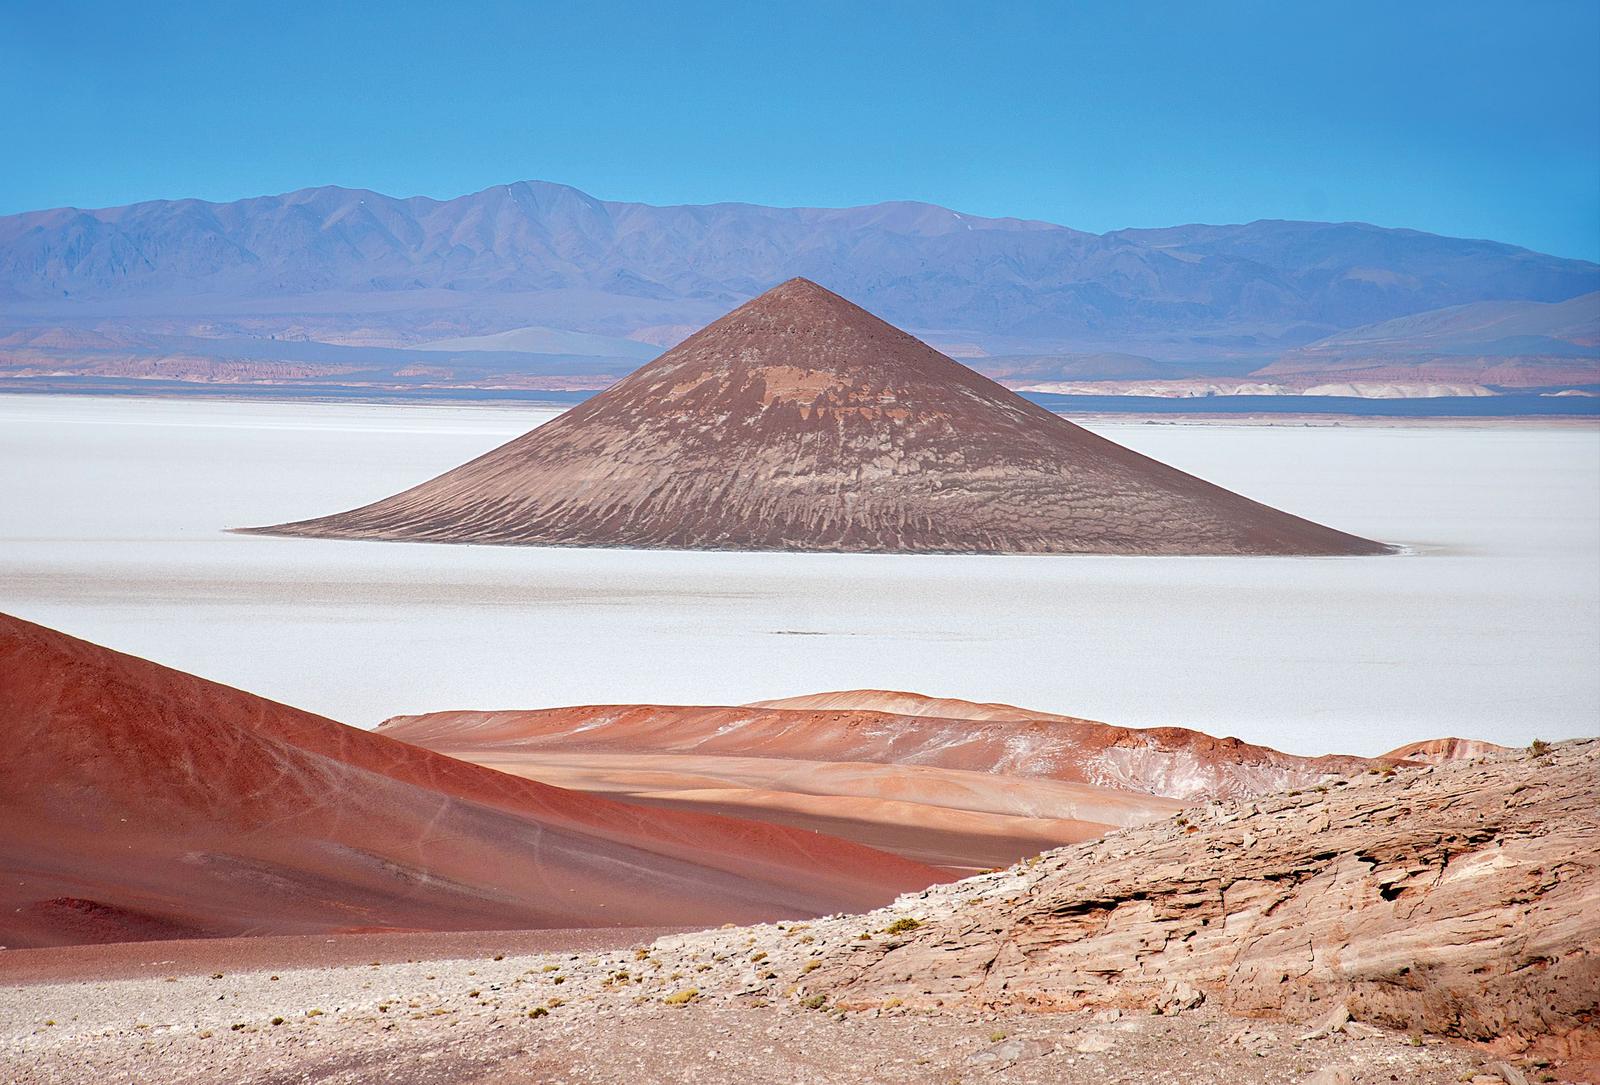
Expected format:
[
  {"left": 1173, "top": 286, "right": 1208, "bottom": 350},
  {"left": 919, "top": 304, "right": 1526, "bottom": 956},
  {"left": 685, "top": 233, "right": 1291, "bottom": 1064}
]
[{"left": 810, "top": 741, "right": 1600, "bottom": 1055}]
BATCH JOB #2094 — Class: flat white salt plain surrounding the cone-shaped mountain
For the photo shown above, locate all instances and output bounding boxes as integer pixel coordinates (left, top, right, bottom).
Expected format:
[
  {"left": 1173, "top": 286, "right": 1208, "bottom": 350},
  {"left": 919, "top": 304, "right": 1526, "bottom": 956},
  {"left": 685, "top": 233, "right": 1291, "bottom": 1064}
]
[{"left": 0, "top": 397, "right": 1600, "bottom": 754}]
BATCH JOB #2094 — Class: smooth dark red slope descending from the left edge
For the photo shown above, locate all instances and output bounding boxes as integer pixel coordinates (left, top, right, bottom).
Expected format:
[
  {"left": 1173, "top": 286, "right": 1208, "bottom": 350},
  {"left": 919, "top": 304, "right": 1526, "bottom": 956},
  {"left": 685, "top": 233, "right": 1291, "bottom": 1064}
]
[{"left": 0, "top": 615, "right": 941, "bottom": 947}]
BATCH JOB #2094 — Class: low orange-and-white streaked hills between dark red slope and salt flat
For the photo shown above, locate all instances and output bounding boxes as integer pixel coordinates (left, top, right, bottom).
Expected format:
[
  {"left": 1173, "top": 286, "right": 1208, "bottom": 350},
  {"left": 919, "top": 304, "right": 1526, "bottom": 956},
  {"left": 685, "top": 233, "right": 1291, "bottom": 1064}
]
[{"left": 379, "top": 690, "right": 1408, "bottom": 869}]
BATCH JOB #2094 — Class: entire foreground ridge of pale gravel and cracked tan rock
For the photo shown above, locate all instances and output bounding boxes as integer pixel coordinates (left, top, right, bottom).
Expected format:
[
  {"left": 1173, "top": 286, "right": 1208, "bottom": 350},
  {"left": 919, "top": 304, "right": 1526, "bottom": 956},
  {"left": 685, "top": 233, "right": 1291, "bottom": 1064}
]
[{"left": 0, "top": 741, "right": 1580, "bottom": 1085}]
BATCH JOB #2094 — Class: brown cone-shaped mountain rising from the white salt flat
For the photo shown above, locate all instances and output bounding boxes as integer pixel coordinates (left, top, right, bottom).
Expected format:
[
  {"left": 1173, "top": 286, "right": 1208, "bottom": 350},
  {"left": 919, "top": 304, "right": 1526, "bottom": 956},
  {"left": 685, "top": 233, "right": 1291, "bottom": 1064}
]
[{"left": 254, "top": 278, "right": 1389, "bottom": 554}]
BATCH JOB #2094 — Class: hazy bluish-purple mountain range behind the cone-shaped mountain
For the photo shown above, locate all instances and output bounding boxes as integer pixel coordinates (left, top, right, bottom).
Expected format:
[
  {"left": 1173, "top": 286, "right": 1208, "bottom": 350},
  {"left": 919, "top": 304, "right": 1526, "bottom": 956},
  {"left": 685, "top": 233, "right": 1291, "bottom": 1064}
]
[{"left": 0, "top": 181, "right": 1600, "bottom": 396}]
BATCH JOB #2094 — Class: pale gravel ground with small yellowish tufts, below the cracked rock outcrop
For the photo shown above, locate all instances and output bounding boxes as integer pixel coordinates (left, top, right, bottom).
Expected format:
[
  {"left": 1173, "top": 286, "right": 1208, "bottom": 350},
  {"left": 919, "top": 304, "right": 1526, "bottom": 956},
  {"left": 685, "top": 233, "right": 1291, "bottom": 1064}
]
[{"left": 0, "top": 908, "right": 1539, "bottom": 1085}]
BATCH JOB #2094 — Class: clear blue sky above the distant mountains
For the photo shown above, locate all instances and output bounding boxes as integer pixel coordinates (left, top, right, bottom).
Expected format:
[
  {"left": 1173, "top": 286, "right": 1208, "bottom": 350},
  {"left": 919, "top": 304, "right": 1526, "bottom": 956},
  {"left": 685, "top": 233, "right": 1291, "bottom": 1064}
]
[{"left": 0, "top": 0, "right": 1600, "bottom": 259}]
